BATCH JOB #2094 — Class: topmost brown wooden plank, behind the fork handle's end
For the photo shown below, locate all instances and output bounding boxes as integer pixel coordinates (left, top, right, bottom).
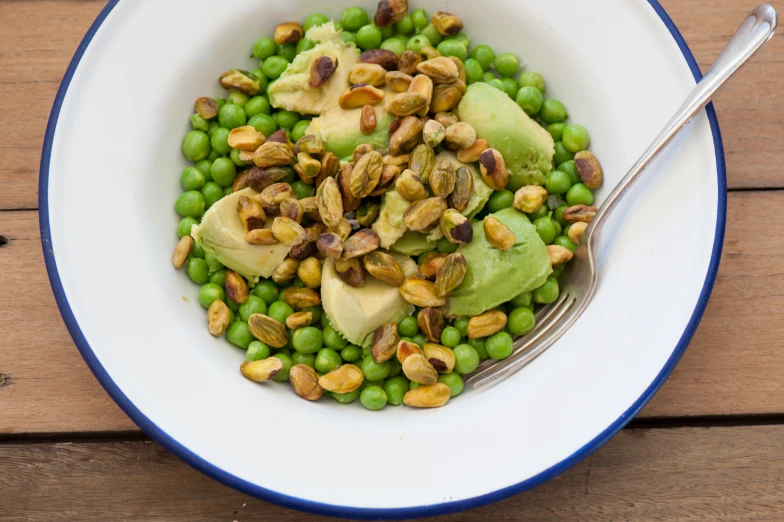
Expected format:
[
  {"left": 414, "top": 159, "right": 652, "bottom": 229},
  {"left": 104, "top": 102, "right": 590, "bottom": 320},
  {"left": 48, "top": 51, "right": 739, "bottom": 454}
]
[{"left": 0, "top": 0, "right": 784, "bottom": 209}]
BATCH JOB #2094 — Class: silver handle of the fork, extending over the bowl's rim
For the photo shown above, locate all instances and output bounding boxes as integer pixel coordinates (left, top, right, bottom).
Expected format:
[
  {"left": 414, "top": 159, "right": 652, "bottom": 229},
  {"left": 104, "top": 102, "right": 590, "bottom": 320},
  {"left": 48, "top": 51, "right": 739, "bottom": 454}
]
[{"left": 584, "top": 5, "right": 778, "bottom": 242}]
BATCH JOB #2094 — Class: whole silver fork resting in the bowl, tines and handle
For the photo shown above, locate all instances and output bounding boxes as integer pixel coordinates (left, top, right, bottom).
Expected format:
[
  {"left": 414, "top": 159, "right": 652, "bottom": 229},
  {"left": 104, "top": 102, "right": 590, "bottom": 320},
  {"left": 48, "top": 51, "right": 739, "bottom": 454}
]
[{"left": 465, "top": 5, "right": 778, "bottom": 389}]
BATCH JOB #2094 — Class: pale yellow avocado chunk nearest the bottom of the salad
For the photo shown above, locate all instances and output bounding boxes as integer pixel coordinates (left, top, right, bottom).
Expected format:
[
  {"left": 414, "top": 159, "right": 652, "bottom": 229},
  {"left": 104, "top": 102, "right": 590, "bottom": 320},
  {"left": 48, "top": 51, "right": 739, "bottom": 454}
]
[{"left": 321, "top": 254, "right": 418, "bottom": 347}]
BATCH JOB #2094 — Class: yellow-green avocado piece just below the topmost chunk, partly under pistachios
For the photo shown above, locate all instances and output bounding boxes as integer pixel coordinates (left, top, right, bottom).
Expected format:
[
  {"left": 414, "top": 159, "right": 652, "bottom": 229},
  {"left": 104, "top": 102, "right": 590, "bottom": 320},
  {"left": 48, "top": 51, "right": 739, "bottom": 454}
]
[{"left": 307, "top": 101, "right": 395, "bottom": 161}]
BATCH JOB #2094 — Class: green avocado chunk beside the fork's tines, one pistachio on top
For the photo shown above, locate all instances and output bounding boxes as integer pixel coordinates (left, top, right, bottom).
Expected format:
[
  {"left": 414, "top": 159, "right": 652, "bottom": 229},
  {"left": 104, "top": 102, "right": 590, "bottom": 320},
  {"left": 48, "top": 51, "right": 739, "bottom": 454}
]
[{"left": 447, "top": 208, "right": 553, "bottom": 317}]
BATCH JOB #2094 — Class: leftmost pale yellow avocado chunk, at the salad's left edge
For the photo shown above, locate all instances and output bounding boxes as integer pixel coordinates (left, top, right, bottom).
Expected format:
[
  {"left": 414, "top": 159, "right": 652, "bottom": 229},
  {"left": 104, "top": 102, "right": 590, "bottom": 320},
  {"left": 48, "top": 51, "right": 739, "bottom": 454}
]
[{"left": 191, "top": 188, "right": 291, "bottom": 284}]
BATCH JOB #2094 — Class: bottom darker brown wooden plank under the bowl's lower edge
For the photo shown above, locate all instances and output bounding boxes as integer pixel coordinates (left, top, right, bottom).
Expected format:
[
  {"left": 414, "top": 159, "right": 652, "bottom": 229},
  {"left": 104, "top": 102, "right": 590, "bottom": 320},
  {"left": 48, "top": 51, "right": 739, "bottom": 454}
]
[{"left": 0, "top": 426, "right": 784, "bottom": 522}]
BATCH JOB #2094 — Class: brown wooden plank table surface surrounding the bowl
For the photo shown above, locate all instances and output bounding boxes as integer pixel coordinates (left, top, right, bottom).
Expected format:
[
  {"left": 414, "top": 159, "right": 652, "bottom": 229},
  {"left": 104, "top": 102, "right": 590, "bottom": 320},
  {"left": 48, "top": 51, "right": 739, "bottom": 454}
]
[{"left": 0, "top": 0, "right": 784, "bottom": 521}]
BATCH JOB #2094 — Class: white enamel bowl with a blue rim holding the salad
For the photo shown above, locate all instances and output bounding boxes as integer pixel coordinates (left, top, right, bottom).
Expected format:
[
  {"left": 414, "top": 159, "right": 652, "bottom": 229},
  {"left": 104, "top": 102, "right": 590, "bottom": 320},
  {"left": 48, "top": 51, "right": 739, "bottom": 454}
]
[{"left": 40, "top": 0, "right": 726, "bottom": 518}]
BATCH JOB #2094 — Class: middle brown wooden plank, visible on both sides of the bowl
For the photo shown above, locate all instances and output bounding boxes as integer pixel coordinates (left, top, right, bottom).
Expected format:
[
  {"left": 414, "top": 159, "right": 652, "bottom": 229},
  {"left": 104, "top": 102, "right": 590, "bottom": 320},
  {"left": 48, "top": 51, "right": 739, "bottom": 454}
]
[{"left": 0, "top": 192, "right": 784, "bottom": 433}]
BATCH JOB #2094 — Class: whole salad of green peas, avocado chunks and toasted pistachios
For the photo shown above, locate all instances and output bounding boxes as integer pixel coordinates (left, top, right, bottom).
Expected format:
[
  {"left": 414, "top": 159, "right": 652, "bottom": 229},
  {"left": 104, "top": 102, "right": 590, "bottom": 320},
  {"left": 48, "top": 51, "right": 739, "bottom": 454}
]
[{"left": 173, "top": 0, "right": 603, "bottom": 410}]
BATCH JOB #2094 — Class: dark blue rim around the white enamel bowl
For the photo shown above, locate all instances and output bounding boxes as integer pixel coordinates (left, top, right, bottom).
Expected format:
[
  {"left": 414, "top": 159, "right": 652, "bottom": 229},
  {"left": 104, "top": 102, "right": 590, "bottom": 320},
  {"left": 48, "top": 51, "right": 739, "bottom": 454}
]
[{"left": 38, "top": 0, "right": 727, "bottom": 520}]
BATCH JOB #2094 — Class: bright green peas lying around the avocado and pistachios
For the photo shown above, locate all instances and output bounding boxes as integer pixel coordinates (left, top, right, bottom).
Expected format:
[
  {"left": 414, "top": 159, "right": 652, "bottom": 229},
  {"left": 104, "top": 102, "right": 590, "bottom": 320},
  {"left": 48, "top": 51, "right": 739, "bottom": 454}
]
[{"left": 175, "top": 7, "right": 593, "bottom": 411}]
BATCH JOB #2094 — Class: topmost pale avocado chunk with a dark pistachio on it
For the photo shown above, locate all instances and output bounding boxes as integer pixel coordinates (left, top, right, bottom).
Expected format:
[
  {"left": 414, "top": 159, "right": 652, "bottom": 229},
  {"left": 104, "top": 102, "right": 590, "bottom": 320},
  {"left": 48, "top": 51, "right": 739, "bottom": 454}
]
[{"left": 267, "top": 22, "right": 359, "bottom": 115}]
